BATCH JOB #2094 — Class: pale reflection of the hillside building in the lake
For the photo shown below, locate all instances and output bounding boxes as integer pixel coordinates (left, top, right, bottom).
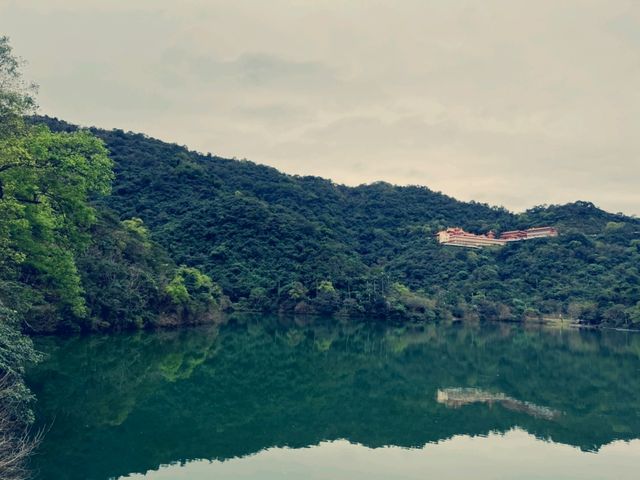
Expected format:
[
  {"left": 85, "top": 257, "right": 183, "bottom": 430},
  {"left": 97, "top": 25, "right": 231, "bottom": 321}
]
[{"left": 436, "top": 388, "right": 560, "bottom": 420}]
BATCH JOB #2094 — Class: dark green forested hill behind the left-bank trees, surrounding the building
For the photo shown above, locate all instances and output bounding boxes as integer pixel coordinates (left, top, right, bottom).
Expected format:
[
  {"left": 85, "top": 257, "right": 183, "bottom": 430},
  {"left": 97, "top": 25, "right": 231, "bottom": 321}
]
[{"left": 38, "top": 117, "right": 640, "bottom": 325}]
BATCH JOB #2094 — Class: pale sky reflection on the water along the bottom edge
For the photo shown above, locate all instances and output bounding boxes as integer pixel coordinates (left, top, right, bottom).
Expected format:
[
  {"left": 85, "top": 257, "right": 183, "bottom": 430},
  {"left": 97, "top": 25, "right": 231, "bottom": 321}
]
[{"left": 121, "top": 429, "right": 640, "bottom": 480}]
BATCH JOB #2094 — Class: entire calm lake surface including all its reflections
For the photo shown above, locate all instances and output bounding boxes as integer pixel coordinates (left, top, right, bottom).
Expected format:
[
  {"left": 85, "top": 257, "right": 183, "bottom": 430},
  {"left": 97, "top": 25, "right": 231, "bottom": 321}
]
[{"left": 29, "top": 317, "right": 640, "bottom": 480}]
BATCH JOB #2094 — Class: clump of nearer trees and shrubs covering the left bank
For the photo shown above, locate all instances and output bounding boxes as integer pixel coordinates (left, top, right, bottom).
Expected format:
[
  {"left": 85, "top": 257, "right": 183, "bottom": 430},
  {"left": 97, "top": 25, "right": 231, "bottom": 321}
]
[{"left": 0, "top": 37, "right": 218, "bottom": 479}]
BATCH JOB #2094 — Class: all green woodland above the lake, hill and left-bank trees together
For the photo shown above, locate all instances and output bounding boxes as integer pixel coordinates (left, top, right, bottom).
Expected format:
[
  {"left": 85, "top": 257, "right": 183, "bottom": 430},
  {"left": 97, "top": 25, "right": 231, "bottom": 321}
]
[{"left": 0, "top": 31, "right": 640, "bottom": 478}]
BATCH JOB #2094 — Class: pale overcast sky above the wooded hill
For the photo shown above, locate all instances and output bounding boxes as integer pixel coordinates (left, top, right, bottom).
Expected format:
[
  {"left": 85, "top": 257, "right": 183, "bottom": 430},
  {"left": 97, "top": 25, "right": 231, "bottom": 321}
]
[{"left": 0, "top": 0, "right": 640, "bottom": 214}]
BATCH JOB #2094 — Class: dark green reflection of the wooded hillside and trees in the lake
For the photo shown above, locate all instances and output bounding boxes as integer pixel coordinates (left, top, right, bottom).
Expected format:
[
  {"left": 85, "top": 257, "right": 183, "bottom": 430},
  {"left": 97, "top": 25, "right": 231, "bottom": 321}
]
[{"left": 31, "top": 317, "right": 640, "bottom": 480}]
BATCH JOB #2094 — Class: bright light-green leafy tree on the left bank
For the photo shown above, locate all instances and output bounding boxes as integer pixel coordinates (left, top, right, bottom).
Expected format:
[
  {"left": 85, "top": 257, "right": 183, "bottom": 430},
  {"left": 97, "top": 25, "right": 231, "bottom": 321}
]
[{"left": 0, "top": 126, "right": 113, "bottom": 317}]
